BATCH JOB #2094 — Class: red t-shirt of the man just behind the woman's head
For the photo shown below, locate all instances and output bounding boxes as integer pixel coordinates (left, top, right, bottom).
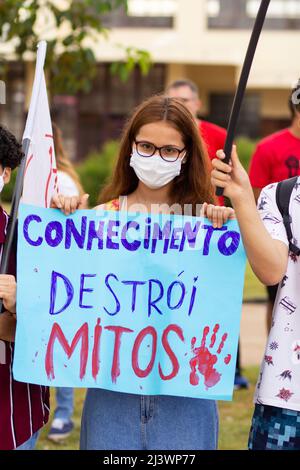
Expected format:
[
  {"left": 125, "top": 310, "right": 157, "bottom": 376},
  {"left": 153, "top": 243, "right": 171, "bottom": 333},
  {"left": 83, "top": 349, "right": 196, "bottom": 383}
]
[{"left": 199, "top": 121, "right": 227, "bottom": 206}]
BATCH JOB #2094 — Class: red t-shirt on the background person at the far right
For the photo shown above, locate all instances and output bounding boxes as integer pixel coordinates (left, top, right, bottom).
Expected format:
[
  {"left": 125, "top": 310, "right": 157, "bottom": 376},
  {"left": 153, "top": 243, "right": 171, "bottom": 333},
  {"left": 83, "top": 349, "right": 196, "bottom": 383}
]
[{"left": 249, "top": 129, "right": 300, "bottom": 188}]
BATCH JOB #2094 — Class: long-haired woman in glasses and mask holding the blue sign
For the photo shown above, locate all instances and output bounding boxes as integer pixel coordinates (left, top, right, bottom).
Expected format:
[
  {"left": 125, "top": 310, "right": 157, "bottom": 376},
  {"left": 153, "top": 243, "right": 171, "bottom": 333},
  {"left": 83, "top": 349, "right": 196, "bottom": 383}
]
[{"left": 54, "top": 96, "right": 232, "bottom": 450}]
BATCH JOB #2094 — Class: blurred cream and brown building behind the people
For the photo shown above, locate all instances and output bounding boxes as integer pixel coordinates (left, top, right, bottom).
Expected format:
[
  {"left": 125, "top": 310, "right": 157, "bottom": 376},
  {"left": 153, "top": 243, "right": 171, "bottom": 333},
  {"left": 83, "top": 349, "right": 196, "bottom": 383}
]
[{"left": 0, "top": 0, "right": 300, "bottom": 159}]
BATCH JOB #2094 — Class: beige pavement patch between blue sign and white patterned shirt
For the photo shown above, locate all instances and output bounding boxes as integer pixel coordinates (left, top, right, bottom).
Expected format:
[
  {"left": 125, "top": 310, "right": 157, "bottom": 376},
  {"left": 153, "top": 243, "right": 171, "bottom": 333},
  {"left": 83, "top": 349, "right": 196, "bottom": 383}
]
[{"left": 240, "top": 303, "right": 267, "bottom": 367}]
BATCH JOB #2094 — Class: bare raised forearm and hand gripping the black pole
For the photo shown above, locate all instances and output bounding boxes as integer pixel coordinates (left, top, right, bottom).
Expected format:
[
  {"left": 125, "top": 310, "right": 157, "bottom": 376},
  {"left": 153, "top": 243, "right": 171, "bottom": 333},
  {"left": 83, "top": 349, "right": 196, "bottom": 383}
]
[{"left": 212, "top": 147, "right": 288, "bottom": 285}]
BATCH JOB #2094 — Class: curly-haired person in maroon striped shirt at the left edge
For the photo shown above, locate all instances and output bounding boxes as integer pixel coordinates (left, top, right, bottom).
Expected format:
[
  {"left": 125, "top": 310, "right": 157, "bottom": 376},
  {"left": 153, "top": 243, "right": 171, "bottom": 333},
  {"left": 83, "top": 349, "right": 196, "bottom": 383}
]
[{"left": 0, "top": 126, "right": 49, "bottom": 450}]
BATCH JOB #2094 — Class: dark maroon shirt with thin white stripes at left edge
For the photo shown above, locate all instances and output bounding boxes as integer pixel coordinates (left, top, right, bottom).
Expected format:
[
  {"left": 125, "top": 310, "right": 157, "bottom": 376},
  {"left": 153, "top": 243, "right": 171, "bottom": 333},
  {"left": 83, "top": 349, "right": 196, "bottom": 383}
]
[{"left": 0, "top": 206, "right": 49, "bottom": 450}]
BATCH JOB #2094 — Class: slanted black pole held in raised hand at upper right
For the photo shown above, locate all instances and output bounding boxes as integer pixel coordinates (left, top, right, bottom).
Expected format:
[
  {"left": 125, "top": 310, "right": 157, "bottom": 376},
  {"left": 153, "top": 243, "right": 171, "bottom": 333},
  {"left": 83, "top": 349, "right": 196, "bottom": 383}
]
[{"left": 216, "top": 0, "right": 271, "bottom": 196}]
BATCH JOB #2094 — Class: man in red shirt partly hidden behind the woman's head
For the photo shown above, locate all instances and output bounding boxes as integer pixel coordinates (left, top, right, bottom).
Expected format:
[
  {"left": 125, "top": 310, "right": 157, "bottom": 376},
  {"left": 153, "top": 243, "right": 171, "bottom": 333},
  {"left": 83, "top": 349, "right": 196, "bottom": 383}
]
[{"left": 165, "top": 79, "right": 249, "bottom": 390}]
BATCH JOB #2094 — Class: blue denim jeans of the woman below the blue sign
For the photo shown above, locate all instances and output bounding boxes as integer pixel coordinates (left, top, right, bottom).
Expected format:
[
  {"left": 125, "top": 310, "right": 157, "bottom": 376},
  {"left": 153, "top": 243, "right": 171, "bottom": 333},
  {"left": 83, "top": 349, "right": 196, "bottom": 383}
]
[{"left": 80, "top": 389, "right": 218, "bottom": 450}]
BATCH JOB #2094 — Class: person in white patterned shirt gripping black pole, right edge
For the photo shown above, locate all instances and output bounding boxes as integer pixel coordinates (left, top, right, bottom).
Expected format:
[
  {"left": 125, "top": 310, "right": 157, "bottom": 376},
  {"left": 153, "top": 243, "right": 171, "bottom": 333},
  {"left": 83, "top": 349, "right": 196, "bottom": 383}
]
[{"left": 212, "top": 149, "right": 300, "bottom": 450}]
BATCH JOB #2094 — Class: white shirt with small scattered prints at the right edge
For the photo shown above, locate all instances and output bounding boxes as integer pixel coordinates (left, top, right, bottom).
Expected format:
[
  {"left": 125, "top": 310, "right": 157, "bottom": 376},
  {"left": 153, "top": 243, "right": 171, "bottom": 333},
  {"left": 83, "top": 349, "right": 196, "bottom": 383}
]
[{"left": 254, "top": 177, "right": 300, "bottom": 411}]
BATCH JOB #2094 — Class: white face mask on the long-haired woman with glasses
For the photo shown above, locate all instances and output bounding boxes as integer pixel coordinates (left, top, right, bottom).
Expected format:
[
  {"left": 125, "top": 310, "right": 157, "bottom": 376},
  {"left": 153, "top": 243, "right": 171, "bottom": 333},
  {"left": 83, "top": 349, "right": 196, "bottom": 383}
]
[{"left": 130, "top": 149, "right": 182, "bottom": 189}]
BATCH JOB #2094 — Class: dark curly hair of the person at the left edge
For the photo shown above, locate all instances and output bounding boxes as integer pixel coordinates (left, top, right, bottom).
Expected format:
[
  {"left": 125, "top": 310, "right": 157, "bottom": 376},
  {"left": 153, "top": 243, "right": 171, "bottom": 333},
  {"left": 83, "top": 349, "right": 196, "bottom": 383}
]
[{"left": 0, "top": 125, "right": 24, "bottom": 170}]
